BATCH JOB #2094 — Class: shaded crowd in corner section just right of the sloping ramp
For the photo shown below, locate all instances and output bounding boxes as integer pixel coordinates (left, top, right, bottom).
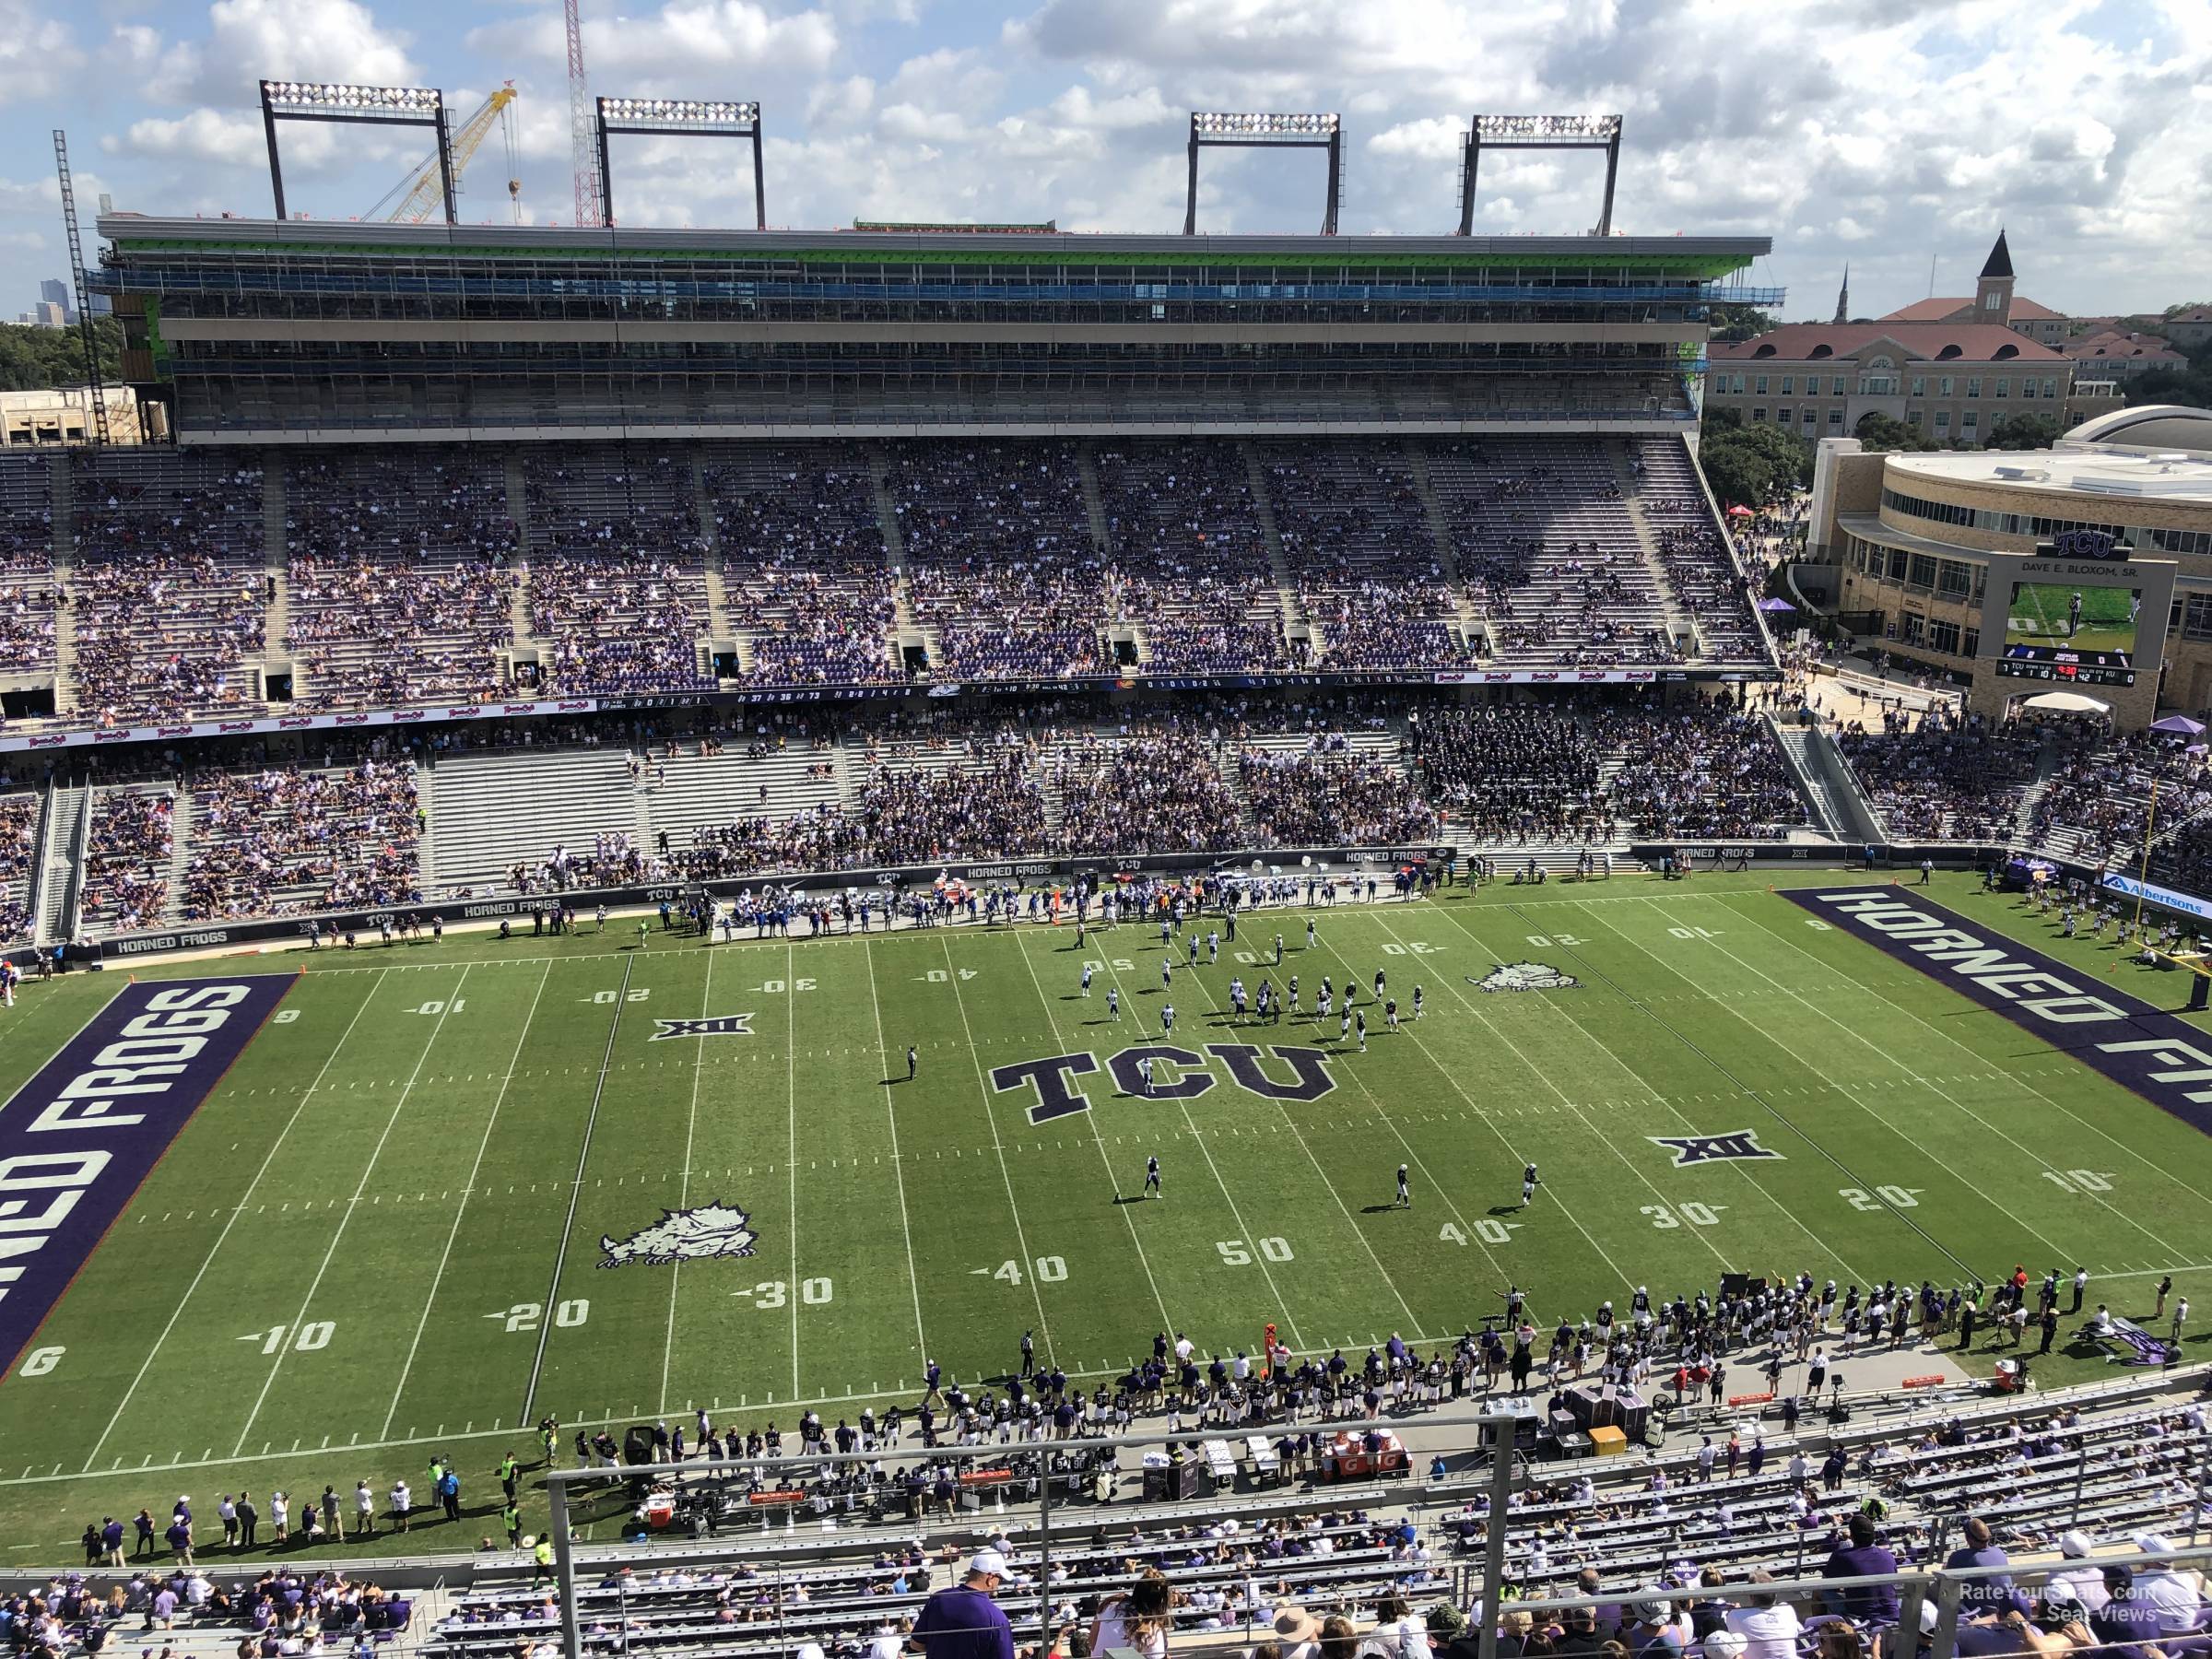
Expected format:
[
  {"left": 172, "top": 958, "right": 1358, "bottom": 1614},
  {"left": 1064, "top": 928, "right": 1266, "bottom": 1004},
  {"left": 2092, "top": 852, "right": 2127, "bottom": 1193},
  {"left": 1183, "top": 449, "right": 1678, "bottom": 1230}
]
[{"left": 1836, "top": 706, "right": 2041, "bottom": 841}]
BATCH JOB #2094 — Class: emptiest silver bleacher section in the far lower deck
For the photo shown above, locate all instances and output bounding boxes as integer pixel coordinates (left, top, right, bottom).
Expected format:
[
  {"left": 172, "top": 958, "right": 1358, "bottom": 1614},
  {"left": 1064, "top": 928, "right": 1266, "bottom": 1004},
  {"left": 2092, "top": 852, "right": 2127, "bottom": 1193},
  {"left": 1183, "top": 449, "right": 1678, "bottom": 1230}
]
[{"left": 429, "top": 747, "right": 637, "bottom": 889}]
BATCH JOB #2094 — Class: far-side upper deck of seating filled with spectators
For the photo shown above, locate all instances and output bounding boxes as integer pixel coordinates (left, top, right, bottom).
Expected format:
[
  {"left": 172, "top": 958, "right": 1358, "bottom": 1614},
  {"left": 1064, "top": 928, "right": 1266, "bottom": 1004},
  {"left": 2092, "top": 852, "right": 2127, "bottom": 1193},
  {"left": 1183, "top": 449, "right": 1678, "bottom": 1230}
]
[{"left": 0, "top": 433, "right": 1768, "bottom": 725}]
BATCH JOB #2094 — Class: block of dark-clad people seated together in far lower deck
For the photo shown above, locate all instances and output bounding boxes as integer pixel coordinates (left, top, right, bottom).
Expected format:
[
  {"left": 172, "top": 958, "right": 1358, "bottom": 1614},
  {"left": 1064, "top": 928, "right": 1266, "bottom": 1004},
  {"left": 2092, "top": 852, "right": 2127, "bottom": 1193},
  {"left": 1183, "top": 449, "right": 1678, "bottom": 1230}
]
[{"left": 1411, "top": 703, "right": 1613, "bottom": 845}]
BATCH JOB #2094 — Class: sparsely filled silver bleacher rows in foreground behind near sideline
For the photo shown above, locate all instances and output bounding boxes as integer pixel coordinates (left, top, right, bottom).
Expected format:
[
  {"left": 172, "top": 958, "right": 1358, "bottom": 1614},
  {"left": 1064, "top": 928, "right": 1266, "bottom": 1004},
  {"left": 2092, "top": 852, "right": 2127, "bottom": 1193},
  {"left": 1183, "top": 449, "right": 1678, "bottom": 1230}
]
[{"left": 406, "top": 1376, "right": 2207, "bottom": 1657}]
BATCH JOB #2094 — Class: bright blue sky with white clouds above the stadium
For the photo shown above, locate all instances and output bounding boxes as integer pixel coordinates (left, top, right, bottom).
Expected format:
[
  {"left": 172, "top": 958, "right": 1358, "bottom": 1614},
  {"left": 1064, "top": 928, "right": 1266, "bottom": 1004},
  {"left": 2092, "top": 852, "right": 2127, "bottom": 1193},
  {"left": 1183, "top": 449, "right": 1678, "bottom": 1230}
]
[{"left": 0, "top": 0, "right": 2212, "bottom": 319}]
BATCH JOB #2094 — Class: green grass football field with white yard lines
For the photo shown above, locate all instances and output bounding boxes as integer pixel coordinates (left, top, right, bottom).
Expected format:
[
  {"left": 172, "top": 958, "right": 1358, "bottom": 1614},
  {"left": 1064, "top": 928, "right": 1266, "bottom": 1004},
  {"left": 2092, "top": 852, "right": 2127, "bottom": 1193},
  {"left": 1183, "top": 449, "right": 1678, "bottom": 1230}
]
[{"left": 0, "top": 872, "right": 2212, "bottom": 1566}]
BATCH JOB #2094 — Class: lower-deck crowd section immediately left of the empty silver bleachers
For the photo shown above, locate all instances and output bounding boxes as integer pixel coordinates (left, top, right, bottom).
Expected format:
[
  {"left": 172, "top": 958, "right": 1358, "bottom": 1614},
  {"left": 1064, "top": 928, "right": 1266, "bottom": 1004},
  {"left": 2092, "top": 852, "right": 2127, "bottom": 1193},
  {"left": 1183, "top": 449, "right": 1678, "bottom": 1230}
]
[{"left": 183, "top": 761, "right": 422, "bottom": 920}]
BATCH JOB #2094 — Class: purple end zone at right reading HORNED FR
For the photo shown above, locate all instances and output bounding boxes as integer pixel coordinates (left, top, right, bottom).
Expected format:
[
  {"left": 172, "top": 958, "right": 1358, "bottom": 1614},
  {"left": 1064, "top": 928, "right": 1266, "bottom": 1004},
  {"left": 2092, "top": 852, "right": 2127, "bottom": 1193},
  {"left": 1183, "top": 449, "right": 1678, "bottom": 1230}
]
[{"left": 1781, "top": 887, "right": 2212, "bottom": 1135}]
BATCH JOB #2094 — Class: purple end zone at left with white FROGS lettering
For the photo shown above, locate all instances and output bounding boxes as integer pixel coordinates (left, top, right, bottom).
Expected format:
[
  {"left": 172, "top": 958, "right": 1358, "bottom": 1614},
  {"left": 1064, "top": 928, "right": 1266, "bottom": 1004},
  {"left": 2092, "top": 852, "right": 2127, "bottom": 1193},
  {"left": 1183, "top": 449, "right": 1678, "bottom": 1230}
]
[{"left": 0, "top": 973, "right": 294, "bottom": 1373}]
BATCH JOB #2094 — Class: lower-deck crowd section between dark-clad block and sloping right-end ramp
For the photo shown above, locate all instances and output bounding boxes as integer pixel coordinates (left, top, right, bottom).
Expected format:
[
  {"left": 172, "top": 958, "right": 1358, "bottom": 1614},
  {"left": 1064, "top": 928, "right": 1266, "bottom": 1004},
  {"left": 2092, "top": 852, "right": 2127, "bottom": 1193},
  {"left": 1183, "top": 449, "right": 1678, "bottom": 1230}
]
[{"left": 1597, "top": 699, "right": 1807, "bottom": 841}]
